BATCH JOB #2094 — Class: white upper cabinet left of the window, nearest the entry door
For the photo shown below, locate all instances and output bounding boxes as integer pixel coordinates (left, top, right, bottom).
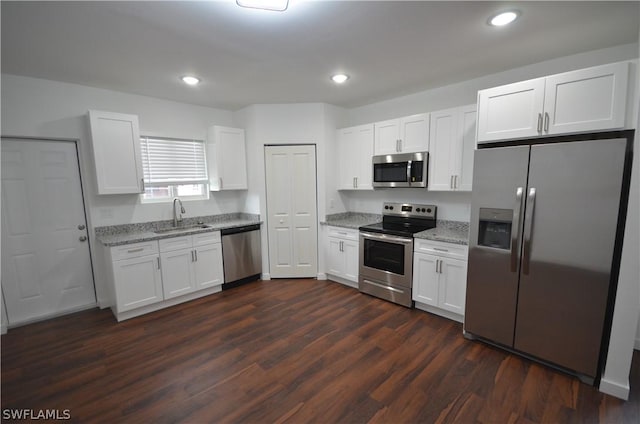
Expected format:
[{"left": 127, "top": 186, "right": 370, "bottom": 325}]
[{"left": 89, "top": 110, "right": 144, "bottom": 194}]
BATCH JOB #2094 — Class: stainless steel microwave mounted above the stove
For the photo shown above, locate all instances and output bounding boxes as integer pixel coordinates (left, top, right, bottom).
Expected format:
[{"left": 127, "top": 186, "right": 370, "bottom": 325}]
[{"left": 373, "top": 152, "right": 429, "bottom": 187}]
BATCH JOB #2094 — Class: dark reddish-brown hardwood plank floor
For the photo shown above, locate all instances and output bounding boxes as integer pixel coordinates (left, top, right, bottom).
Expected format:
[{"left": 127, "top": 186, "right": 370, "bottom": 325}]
[{"left": 1, "top": 280, "right": 640, "bottom": 423}]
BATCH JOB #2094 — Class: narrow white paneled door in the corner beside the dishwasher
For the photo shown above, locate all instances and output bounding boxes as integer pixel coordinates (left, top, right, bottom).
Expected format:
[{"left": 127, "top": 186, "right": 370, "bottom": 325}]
[{"left": 265, "top": 145, "right": 318, "bottom": 278}]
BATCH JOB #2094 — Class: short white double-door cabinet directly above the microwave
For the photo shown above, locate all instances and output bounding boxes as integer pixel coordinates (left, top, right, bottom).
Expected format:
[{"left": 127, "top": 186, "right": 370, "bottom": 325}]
[{"left": 374, "top": 113, "right": 429, "bottom": 155}]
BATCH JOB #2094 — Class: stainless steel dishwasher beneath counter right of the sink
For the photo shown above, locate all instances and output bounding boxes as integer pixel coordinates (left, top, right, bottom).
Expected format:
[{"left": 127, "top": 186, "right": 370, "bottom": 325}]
[{"left": 220, "top": 224, "right": 262, "bottom": 290}]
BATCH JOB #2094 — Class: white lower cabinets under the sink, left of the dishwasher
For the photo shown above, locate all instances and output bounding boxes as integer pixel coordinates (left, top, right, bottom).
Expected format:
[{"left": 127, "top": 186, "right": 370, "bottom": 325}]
[{"left": 106, "top": 231, "right": 224, "bottom": 321}]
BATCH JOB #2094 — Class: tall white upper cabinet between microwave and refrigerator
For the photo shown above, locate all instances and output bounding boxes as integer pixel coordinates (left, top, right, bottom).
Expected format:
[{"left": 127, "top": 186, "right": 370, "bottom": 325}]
[{"left": 429, "top": 105, "right": 476, "bottom": 191}]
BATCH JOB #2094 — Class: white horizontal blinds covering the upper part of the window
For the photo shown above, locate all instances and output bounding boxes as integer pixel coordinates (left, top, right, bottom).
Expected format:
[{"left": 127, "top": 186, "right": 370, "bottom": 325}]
[{"left": 140, "top": 137, "right": 208, "bottom": 187}]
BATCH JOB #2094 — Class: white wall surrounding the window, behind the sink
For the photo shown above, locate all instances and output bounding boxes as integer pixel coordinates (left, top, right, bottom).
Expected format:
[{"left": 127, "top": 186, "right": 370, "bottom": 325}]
[{"left": 1, "top": 74, "right": 245, "bottom": 306}]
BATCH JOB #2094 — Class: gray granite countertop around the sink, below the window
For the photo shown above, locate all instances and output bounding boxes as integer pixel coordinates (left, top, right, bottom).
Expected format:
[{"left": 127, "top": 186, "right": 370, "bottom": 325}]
[{"left": 96, "top": 213, "right": 262, "bottom": 247}]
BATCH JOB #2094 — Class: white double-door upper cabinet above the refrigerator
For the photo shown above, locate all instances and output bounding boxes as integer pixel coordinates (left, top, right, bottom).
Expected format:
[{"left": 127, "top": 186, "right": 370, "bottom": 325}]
[{"left": 478, "top": 62, "right": 629, "bottom": 143}]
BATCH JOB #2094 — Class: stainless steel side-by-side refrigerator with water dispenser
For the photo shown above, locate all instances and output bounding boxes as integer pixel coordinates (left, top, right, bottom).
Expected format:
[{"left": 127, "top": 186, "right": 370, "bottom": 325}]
[{"left": 464, "top": 132, "right": 632, "bottom": 383}]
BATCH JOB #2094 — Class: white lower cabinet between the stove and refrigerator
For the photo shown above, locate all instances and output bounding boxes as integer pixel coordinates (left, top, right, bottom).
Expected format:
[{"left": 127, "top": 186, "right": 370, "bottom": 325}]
[{"left": 413, "top": 240, "right": 468, "bottom": 322}]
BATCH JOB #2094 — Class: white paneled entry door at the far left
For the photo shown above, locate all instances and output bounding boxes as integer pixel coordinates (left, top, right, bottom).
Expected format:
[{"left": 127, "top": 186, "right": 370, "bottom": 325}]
[{"left": 2, "top": 138, "right": 96, "bottom": 325}]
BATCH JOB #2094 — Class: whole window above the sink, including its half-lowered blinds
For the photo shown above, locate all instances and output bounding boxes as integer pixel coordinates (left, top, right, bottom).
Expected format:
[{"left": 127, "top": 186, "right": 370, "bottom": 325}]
[{"left": 140, "top": 137, "right": 209, "bottom": 203}]
